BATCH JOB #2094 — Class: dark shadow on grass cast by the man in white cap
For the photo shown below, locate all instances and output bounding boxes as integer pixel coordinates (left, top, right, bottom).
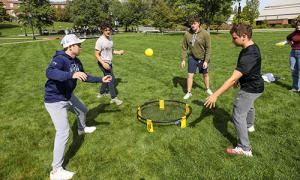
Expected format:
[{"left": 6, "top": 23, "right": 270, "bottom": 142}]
[{"left": 63, "top": 104, "right": 120, "bottom": 167}]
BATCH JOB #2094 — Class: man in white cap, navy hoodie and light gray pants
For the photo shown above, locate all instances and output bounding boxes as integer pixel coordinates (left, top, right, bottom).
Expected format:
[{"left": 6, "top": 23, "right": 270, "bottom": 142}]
[{"left": 44, "top": 34, "right": 112, "bottom": 179}]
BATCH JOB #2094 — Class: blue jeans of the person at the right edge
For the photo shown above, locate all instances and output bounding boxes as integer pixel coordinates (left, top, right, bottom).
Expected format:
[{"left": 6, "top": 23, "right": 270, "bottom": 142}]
[{"left": 290, "top": 49, "right": 300, "bottom": 90}]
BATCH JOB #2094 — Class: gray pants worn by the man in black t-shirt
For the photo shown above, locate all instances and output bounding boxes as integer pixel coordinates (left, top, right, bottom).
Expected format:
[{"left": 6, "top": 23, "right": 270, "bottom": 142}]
[{"left": 233, "top": 90, "right": 262, "bottom": 151}]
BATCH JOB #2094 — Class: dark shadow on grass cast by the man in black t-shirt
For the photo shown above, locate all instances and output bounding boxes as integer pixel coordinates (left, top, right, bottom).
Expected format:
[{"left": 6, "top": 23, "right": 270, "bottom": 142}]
[{"left": 189, "top": 100, "right": 237, "bottom": 145}]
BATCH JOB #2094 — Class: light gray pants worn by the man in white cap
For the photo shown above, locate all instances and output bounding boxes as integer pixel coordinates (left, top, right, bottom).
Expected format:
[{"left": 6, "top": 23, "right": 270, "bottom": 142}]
[{"left": 45, "top": 95, "right": 88, "bottom": 169}]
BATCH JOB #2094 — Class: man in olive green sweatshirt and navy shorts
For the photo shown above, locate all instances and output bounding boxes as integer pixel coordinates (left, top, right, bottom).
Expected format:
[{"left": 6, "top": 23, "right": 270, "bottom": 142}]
[{"left": 181, "top": 17, "right": 212, "bottom": 100}]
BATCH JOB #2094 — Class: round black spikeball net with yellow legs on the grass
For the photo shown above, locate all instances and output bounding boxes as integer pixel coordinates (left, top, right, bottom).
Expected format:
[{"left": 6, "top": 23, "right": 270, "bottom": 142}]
[{"left": 137, "top": 100, "right": 192, "bottom": 132}]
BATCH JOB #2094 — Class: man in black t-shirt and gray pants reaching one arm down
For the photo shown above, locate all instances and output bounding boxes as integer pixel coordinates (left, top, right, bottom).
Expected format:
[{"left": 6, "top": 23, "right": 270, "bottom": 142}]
[{"left": 204, "top": 24, "right": 264, "bottom": 156}]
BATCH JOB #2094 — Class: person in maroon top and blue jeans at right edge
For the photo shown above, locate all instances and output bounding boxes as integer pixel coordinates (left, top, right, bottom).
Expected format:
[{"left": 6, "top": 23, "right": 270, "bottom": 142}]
[{"left": 286, "top": 20, "right": 300, "bottom": 92}]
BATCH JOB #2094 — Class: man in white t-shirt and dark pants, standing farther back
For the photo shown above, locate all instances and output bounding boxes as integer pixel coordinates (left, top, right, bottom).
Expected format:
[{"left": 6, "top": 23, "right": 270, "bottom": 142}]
[{"left": 95, "top": 22, "right": 124, "bottom": 105}]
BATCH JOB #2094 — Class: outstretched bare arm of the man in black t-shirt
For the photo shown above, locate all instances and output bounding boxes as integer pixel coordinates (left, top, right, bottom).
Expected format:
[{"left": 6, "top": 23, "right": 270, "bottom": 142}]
[{"left": 204, "top": 70, "right": 243, "bottom": 108}]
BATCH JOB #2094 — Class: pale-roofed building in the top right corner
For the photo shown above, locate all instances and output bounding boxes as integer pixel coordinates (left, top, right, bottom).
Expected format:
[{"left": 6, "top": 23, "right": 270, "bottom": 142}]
[{"left": 256, "top": 0, "right": 300, "bottom": 25}]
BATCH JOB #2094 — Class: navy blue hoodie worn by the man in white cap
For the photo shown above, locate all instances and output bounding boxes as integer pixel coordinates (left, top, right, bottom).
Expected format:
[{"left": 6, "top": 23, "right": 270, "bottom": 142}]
[{"left": 44, "top": 51, "right": 102, "bottom": 103}]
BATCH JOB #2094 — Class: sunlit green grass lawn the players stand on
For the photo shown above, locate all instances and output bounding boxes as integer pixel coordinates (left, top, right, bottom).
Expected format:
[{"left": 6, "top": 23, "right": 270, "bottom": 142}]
[{"left": 0, "top": 32, "right": 300, "bottom": 179}]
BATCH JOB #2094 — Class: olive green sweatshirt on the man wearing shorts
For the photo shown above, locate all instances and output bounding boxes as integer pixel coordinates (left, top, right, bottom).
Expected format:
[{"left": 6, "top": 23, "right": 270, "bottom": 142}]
[{"left": 182, "top": 28, "right": 211, "bottom": 62}]
